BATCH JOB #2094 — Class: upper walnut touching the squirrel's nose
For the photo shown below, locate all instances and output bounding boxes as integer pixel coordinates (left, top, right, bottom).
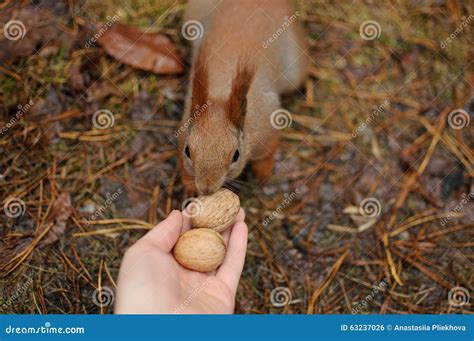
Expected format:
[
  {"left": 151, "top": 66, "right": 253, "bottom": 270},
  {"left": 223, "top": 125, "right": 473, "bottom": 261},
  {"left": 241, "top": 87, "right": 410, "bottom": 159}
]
[{"left": 191, "top": 188, "right": 240, "bottom": 233}]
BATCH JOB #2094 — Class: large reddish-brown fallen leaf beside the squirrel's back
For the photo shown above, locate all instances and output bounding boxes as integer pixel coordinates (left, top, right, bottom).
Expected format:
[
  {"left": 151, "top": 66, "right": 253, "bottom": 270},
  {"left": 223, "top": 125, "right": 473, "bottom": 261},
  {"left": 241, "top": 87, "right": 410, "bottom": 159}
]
[{"left": 97, "top": 24, "right": 184, "bottom": 74}]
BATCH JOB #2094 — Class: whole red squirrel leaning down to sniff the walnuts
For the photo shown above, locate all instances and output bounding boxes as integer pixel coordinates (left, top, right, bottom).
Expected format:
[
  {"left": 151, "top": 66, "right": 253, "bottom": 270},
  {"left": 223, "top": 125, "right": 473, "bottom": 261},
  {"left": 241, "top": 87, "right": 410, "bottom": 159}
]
[{"left": 179, "top": 0, "right": 308, "bottom": 194}]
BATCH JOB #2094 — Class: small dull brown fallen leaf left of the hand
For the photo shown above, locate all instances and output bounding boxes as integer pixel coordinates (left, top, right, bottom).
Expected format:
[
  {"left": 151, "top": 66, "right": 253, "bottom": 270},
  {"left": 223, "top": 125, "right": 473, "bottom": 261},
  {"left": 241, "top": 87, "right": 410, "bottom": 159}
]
[{"left": 37, "top": 193, "right": 72, "bottom": 246}]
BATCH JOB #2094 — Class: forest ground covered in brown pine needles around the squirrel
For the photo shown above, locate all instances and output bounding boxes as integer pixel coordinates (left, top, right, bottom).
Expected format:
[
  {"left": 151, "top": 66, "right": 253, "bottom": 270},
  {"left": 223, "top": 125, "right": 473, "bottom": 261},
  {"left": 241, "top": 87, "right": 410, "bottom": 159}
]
[{"left": 0, "top": 0, "right": 474, "bottom": 314}]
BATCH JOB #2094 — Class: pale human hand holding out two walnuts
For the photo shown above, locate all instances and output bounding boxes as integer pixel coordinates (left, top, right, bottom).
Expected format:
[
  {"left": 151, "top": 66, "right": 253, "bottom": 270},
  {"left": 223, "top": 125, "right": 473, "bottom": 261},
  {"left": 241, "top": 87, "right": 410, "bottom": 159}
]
[{"left": 115, "top": 209, "right": 248, "bottom": 314}]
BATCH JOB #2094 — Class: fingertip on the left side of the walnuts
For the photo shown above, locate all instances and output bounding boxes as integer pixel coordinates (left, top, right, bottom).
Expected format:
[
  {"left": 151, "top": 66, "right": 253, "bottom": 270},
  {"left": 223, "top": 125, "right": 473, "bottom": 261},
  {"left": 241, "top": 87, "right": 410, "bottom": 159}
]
[{"left": 141, "top": 210, "right": 183, "bottom": 252}]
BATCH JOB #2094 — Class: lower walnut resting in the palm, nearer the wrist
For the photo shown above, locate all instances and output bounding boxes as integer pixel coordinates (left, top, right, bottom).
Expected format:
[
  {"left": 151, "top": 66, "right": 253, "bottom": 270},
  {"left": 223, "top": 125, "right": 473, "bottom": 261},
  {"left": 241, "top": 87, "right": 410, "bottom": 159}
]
[{"left": 173, "top": 229, "right": 226, "bottom": 272}]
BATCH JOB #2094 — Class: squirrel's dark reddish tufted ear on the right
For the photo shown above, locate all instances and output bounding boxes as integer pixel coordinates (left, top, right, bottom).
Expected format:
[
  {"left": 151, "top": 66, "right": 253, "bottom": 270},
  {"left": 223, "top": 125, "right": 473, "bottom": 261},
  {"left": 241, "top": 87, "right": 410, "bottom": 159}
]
[{"left": 227, "top": 61, "right": 255, "bottom": 129}]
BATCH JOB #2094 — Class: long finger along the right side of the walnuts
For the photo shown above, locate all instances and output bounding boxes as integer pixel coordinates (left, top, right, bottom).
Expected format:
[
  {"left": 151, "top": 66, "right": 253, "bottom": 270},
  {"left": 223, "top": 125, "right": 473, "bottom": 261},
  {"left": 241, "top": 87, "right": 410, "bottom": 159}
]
[{"left": 216, "top": 222, "right": 248, "bottom": 295}]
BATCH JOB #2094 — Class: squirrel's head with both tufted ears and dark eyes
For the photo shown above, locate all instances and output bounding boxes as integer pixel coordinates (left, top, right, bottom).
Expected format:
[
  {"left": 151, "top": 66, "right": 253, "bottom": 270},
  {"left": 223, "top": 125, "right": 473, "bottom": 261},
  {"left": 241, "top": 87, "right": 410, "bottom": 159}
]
[{"left": 180, "top": 50, "right": 255, "bottom": 194}]
